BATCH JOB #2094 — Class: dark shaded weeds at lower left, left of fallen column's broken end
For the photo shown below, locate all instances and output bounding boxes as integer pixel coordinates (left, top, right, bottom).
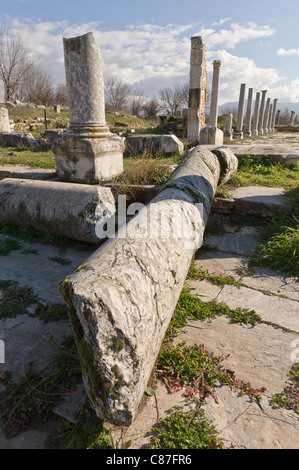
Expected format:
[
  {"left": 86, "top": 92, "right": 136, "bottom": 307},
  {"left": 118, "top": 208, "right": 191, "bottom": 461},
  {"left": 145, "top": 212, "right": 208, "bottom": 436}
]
[{"left": 0, "top": 338, "right": 81, "bottom": 438}]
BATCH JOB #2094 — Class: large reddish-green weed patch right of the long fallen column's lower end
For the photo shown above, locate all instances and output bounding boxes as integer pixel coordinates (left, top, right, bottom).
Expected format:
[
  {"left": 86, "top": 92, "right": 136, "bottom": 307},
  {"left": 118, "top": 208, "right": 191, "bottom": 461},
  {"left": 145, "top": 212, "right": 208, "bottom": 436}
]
[{"left": 156, "top": 341, "right": 265, "bottom": 403}]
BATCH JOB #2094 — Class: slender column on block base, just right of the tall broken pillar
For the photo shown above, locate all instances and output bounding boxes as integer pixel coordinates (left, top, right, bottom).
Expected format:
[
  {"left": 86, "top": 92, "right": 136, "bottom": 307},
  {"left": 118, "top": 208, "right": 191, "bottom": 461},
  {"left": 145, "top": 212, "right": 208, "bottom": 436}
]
[{"left": 199, "top": 60, "right": 223, "bottom": 145}]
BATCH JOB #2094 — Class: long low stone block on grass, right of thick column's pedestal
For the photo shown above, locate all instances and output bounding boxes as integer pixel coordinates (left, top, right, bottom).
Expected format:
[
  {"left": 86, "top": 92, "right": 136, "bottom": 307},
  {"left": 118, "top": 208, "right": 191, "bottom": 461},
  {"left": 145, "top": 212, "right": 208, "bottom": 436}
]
[{"left": 126, "top": 135, "right": 184, "bottom": 155}]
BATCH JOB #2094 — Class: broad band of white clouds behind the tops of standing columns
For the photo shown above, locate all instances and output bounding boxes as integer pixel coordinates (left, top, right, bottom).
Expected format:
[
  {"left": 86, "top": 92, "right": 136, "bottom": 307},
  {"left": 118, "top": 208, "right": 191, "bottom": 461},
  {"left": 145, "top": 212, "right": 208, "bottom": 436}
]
[{"left": 3, "top": 18, "right": 284, "bottom": 103}]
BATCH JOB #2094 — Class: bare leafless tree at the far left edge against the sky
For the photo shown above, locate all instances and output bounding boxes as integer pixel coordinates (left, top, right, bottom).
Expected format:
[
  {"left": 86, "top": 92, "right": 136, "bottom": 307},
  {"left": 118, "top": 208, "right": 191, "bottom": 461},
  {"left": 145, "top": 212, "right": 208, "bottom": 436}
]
[{"left": 0, "top": 26, "right": 34, "bottom": 101}]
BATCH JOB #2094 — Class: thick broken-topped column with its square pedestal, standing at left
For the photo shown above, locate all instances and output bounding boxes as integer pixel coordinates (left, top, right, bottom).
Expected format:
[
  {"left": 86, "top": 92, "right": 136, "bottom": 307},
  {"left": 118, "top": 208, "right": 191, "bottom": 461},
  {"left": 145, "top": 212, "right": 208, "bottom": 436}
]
[{"left": 53, "top": 32, "right": 124, "bottom": 184}]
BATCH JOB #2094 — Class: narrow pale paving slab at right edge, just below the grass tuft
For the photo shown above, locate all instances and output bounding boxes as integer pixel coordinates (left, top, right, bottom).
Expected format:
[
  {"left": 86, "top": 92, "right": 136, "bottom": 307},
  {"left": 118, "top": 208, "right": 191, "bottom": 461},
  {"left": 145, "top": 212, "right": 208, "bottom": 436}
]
[{"left": 217, "top": 285, "right": 299, "bottom": 332}]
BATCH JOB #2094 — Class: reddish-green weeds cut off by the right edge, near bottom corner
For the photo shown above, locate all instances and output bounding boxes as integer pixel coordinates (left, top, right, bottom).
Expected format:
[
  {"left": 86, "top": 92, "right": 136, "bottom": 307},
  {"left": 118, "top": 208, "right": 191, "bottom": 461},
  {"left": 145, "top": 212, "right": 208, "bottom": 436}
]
[{"left": 271, "top": 362, "right": 299, "bottom": 414}]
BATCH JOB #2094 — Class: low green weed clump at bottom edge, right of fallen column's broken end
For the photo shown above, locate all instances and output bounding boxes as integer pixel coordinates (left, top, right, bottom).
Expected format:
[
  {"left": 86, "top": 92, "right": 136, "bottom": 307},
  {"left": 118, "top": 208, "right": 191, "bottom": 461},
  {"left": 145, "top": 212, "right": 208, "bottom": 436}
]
[{"left": 150, "top": 407, "right": 224, "bottom": 449}]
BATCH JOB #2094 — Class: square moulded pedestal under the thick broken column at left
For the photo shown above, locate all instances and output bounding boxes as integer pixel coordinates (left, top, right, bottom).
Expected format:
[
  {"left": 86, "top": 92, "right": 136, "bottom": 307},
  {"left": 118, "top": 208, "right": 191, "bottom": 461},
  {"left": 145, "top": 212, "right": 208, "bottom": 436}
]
[{"left": 52, "top": 131, "right": 124, "bottom": 184}]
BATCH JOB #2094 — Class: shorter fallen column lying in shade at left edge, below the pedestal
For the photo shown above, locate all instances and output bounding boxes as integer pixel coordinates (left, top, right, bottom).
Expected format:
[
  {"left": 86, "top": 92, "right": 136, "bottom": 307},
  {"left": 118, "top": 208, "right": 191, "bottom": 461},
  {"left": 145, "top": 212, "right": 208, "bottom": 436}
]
[{"left": 0, "top": 178, "right": 115, "bottom": 244}]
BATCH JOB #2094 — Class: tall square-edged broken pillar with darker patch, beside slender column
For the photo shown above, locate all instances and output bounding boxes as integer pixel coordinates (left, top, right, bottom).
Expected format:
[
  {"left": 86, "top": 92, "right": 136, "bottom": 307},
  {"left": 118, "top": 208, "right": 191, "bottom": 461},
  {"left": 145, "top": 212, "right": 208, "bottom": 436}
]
[{"left": 187, "top": 36, "right": 208, "bottom": 140}]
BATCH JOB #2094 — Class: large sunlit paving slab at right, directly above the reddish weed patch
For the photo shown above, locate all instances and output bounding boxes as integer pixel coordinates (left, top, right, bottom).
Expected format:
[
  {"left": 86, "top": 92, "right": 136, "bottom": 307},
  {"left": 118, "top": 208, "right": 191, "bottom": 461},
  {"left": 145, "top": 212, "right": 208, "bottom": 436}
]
[{"left": 174, "top": 317, "right": 299, "bottom": 394}]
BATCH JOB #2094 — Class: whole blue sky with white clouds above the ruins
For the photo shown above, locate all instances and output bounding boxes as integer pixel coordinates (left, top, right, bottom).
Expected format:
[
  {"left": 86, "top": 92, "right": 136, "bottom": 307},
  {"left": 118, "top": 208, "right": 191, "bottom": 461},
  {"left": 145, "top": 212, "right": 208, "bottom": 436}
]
[{"left": 0, "top": 0, "right": 299, "bottom": 104}]
